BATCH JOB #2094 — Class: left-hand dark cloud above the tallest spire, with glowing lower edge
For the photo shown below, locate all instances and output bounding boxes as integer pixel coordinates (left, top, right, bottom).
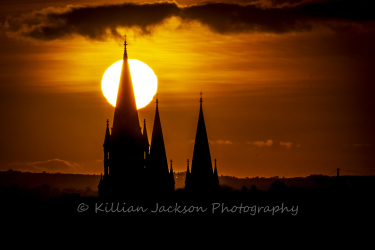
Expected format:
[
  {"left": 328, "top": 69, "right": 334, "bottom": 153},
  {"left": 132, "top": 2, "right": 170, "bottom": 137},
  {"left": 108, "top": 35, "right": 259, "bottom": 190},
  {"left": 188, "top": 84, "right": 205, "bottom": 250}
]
[{"left": 6, "top": 2, "right": 179, "bottom": 40}]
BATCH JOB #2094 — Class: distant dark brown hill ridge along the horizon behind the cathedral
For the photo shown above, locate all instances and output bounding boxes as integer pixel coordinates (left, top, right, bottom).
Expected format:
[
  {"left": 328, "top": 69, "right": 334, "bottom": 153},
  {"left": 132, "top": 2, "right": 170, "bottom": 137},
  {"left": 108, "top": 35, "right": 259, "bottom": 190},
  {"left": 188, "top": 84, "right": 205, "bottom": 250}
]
[{"left": 0, "top": 170, "right": 375, "bottom": 193}]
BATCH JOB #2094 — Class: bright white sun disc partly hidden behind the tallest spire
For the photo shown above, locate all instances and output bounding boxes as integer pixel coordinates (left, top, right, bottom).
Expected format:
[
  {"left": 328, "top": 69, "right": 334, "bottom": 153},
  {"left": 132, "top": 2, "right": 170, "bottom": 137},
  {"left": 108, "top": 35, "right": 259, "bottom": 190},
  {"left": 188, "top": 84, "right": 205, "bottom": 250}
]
[{"left": 102, "top": 59, "right": 158, "bottom": 109}]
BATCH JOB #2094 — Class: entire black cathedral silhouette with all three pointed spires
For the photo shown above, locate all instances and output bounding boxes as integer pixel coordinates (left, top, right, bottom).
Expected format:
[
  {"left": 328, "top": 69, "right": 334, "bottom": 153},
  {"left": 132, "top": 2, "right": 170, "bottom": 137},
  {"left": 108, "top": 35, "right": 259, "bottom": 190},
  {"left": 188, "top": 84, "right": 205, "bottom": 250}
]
[{"left": 98, "top": 40, "right": 219, "bottom": 197}]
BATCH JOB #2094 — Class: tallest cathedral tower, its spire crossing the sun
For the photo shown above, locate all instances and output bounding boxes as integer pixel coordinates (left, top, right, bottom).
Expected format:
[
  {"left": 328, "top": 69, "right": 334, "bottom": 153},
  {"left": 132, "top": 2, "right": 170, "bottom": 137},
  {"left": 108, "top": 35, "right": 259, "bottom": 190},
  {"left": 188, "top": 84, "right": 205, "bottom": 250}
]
[{"left": 99, "top": 37, "right": 145, "bottom": 196}]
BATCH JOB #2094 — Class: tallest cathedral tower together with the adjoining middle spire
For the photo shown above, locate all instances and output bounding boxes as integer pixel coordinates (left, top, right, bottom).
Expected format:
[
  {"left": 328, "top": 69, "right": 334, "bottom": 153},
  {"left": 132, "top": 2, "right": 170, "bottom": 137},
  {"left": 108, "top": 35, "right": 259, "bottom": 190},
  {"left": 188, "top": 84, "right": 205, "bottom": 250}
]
[{"left": 98, "top": 40, "right": 174, "bottom": 197}]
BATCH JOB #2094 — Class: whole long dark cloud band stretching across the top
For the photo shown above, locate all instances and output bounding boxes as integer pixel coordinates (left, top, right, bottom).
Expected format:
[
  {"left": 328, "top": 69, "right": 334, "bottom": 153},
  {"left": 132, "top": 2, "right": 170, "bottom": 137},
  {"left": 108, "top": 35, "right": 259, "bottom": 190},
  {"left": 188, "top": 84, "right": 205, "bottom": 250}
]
[{"left": 4, "top": 0, "right": 375, "bottom": 40}]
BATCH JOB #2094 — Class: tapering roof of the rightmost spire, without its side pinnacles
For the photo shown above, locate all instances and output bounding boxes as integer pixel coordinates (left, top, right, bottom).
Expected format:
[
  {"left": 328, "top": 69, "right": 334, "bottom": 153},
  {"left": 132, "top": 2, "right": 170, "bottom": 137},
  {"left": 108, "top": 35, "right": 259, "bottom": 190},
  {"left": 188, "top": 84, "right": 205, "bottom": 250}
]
[{"left": 191, "top": 93, "right": 213, "bottom": 177}]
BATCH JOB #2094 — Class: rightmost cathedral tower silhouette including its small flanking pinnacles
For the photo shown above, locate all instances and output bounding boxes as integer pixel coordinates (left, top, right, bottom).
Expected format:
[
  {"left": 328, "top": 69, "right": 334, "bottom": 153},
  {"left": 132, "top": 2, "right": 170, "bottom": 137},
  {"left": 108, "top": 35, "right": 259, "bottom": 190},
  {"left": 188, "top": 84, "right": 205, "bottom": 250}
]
[{"left": 185, "top": 97, "right": 219, "bottom": 191}]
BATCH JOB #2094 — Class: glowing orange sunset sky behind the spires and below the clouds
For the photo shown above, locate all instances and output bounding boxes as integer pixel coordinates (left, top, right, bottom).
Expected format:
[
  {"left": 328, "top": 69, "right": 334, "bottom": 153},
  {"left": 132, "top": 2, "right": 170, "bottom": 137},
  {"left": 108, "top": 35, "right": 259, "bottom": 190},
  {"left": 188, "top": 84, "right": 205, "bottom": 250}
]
[{"left": 0, "top": 0, "right": 375, "bottom": 177}]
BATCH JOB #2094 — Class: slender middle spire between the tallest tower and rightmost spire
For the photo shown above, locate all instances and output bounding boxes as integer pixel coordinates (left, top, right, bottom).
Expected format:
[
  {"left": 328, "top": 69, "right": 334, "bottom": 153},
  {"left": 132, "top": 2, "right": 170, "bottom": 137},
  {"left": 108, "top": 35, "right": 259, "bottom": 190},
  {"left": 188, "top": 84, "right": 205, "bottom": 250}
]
[{"left": 150, "top": 96, "right": 169, "bottom": 174}]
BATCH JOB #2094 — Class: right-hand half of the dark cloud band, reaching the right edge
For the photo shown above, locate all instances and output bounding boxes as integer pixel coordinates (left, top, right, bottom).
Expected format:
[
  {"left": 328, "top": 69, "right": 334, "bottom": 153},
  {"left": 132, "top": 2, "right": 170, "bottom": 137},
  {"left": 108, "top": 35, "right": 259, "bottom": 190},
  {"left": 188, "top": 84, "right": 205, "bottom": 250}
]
[{"left": 182, "top": 0, "right": 375, "bottom": 33}]
